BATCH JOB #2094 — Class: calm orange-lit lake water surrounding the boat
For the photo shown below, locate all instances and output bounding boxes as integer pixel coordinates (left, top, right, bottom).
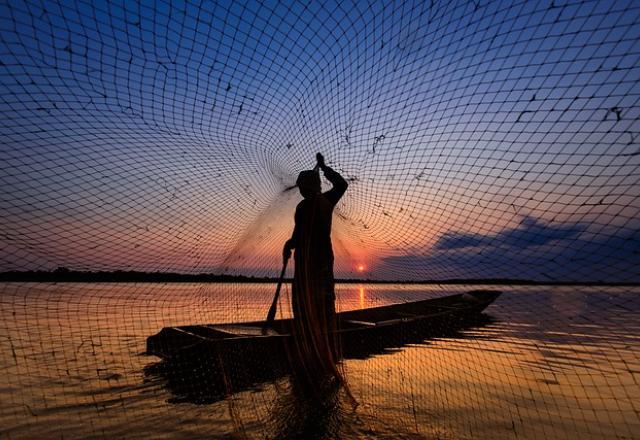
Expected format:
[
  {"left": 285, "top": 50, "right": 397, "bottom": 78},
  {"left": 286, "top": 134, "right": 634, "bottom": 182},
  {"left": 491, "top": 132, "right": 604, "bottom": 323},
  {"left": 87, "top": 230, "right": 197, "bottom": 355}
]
[{"left": 0, "top": 283, "right": 640, "bottom": 440}]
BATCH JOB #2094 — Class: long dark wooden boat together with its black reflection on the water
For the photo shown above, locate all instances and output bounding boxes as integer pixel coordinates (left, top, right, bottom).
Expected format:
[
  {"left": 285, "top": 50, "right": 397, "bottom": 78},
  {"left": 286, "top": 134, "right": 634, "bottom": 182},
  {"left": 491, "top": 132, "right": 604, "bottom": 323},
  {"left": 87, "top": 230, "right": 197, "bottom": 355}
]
[{"left": 145, "top": 290, "right": 500, "bottom": 404}]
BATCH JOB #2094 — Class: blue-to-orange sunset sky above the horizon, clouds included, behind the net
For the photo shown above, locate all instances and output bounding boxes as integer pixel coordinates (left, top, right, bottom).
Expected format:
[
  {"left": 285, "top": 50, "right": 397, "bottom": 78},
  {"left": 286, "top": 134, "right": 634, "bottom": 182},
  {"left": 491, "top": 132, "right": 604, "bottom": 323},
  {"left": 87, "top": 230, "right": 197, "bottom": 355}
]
[{"left": 0, "top": 0, "right": 640, "bottom": 282}]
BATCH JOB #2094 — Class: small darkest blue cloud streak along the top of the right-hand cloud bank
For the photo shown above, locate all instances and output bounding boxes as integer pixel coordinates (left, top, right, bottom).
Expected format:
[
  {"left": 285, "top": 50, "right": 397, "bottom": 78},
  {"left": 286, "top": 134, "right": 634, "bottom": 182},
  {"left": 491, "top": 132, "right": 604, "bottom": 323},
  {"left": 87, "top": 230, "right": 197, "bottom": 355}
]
[{"left": 435, "top": 217, "right": 585, "bottom": 250}]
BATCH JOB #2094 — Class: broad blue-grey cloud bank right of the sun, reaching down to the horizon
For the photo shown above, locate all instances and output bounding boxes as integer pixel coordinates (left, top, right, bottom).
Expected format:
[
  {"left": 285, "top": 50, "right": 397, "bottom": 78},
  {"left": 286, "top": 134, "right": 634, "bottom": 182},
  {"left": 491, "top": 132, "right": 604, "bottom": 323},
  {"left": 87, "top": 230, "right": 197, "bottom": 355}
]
[{"left": 379, "top": 218, "right": 640, "bottom": 282}]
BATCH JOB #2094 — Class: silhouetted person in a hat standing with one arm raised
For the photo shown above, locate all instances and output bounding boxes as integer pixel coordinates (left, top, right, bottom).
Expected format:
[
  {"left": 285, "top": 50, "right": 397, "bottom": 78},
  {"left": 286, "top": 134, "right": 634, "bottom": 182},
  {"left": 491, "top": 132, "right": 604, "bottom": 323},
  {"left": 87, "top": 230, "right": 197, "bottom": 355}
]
[{"left": 283, "top": 153, "right": 348, "bottom": 368}]
